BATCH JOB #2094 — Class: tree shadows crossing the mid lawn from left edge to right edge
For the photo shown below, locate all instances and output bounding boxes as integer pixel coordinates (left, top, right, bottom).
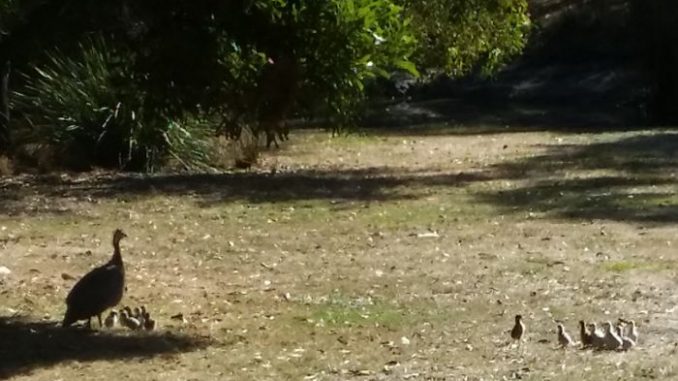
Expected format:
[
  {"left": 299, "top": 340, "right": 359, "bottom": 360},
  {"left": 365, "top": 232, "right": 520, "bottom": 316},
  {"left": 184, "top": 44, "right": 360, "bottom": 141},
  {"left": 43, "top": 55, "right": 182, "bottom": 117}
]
[{"left": 5, "top": 130, "right": 678, "bottom": 223}]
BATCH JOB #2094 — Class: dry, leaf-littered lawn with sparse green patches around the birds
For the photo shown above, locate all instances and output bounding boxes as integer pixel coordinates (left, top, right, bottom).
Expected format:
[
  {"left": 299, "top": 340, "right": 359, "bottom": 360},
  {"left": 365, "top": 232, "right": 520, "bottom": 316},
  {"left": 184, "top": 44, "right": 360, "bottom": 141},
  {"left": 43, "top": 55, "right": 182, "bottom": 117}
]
[{"left": 0, "top": 127, "right": 678, "bottom": 380}]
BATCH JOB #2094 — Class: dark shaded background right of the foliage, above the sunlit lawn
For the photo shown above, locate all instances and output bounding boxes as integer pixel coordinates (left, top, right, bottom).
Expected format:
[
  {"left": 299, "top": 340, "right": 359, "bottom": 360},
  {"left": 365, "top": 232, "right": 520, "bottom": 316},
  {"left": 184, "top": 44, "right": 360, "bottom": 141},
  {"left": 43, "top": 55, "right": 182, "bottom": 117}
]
[{"left": 363, "top": 0, "right": 651, "bottom": 134}]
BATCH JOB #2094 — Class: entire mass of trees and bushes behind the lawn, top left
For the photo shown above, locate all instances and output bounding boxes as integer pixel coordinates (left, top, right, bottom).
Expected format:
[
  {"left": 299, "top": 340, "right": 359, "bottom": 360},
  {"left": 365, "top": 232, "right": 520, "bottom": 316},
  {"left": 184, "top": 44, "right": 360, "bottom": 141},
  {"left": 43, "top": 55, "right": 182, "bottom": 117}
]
[{"left": 0, "top": 0, "right": 529, "bottom": 170}]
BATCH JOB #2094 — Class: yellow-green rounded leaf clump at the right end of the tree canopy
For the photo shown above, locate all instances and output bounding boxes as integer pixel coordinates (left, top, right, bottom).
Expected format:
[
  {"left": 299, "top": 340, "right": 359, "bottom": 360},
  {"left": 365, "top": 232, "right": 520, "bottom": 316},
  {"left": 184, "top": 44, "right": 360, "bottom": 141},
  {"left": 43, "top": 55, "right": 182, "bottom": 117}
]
[{"left": 400, "top": 0, "right": 531, "bottom": 76}]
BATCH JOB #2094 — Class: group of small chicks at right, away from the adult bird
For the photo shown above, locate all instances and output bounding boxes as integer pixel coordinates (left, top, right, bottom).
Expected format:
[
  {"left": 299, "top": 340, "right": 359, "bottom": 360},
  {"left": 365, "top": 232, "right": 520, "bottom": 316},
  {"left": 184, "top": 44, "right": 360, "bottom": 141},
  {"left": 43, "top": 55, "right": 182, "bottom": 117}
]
[{"left": 511, "top": 315, "right": 638, "bottom": 351}]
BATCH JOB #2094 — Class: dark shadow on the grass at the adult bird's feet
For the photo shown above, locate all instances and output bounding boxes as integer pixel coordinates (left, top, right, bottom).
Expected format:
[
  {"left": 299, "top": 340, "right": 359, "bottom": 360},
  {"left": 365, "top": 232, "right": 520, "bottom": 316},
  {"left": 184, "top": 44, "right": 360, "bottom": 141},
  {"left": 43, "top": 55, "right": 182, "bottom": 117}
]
[{"left": 0, "top": 317, "right": 208, "bottom": 379}]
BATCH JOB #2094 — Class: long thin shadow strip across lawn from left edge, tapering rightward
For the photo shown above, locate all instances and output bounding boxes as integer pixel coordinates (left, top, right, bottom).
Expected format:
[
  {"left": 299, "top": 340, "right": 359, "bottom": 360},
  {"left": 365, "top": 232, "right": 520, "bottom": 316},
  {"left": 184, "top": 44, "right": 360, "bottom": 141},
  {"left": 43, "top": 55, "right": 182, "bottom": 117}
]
[{"left": 0, "top": 167, "right": 490, "bottom": 215}]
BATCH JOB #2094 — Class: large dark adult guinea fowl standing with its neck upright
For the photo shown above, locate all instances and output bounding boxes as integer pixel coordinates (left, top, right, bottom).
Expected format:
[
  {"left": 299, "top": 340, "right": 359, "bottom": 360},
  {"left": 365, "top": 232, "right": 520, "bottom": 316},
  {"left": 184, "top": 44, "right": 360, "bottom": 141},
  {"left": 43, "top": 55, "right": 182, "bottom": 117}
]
[{"left": 62, "top": 229, "right": 127, "bottom": 329}]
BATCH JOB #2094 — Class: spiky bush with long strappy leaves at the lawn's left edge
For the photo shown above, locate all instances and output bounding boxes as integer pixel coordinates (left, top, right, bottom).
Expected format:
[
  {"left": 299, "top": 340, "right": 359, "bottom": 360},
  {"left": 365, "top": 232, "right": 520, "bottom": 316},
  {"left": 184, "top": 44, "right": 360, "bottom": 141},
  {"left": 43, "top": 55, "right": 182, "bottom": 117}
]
[{"left": 15, "top": 39, "right": 214, "bottom": 171}]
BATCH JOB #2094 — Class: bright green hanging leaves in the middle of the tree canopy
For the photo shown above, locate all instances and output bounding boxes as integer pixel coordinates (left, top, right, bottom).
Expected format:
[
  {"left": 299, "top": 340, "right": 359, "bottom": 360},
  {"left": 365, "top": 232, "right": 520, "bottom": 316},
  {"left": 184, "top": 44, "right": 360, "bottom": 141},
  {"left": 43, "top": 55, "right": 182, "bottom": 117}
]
[{"left": 300, "top": 0, "right": 417, "bottom": 125}]
